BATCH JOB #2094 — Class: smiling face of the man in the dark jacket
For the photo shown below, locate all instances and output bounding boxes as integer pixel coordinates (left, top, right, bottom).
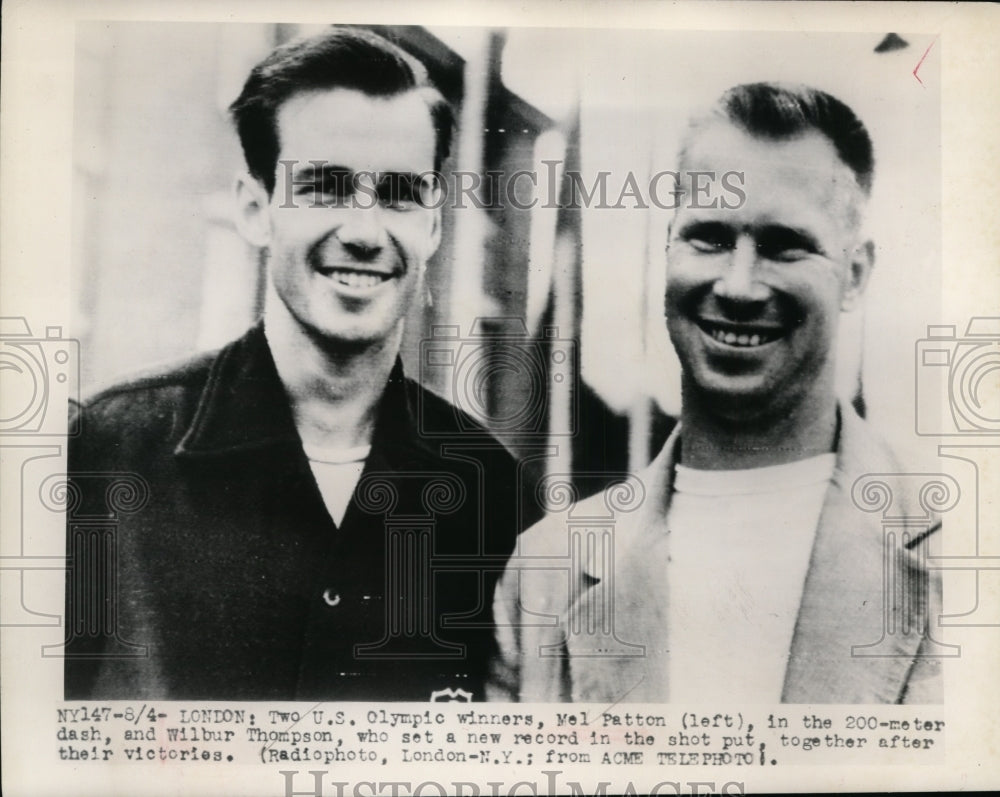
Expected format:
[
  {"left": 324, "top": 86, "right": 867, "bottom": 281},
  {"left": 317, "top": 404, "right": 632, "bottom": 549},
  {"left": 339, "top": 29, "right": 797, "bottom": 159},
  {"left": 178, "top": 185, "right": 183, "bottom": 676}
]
[{"left": 254, "top": 89, "right": 440, "bottom": 345}]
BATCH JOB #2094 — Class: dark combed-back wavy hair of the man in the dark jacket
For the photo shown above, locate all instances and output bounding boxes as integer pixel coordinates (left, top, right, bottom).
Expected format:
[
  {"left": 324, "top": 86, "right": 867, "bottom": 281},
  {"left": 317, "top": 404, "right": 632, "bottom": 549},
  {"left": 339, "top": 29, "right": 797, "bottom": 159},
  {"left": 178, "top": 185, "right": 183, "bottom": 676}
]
[{"left": 229, "top": 27, "right": 454, "bottom": 194}]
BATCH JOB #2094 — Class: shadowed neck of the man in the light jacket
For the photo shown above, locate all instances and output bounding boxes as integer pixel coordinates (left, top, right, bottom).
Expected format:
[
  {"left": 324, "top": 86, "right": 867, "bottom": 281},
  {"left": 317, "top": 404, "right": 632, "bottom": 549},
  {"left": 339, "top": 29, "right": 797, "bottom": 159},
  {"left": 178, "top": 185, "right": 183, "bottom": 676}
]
[{"left": 681, "top": 378, "right": 837, "bottom": 470}]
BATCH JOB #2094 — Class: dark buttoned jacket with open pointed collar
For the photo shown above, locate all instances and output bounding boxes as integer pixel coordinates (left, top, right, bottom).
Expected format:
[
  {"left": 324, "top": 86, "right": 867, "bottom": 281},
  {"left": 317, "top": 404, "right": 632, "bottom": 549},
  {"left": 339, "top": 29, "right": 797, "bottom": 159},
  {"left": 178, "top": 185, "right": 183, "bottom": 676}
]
[{"left": 65, "top": 324, "right": 535, "bottom": 701}]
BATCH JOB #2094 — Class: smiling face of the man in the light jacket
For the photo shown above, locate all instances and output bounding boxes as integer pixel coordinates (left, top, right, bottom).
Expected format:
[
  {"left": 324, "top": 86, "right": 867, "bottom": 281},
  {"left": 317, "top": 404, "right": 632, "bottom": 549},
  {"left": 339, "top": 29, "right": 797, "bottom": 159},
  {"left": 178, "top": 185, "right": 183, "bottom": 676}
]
[{"left": 666, "top": 120, "right": 871, "bottom": 417}]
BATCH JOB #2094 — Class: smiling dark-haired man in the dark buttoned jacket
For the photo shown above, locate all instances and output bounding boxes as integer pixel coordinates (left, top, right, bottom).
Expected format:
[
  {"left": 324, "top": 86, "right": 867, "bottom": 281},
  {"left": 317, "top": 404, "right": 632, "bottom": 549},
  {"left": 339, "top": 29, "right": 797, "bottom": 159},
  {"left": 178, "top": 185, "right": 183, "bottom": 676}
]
[{"left": 65, "top": 29, "right": 521, "bottom": 700}]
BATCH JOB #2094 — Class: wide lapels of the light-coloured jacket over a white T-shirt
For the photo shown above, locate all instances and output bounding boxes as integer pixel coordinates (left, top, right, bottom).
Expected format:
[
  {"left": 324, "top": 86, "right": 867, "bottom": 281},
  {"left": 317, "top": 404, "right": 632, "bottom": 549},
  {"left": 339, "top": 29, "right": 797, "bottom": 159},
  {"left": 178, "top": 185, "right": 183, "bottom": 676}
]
[{"left": 567, "top": 408, "right": 933, "bottom": 703}]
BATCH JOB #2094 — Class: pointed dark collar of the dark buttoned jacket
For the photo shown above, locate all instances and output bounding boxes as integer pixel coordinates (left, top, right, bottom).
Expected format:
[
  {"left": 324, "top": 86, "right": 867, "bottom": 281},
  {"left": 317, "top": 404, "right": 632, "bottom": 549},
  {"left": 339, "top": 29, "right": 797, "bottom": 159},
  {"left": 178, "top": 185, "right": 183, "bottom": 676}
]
[{"left": 174, "top": 322, "right": 437, "bottom": 469}]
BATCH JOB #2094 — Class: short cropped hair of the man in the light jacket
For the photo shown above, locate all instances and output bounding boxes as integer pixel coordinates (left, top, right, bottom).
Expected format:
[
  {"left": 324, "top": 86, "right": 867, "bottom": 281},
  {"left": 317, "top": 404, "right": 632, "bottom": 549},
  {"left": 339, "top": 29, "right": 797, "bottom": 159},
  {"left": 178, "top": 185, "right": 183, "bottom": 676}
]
[{"left": 685, "top": 83, "right": 875, "bottom": 195}]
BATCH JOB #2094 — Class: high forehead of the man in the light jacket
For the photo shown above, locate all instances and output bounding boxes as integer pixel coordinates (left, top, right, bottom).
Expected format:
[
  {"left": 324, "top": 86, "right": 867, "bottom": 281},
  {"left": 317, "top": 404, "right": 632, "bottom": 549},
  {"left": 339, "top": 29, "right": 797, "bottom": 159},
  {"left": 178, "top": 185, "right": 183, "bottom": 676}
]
[{"left": 681, "top": 120, "right": 863, "bottom": 227}]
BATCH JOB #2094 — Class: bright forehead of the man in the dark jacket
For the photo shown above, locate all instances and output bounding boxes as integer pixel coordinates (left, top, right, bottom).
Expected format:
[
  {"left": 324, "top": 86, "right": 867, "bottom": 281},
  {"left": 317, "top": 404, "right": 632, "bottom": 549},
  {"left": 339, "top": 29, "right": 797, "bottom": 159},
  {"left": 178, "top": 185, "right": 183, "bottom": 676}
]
[{"left": 277, "top": 89, "right": 435, "bottom": 172}]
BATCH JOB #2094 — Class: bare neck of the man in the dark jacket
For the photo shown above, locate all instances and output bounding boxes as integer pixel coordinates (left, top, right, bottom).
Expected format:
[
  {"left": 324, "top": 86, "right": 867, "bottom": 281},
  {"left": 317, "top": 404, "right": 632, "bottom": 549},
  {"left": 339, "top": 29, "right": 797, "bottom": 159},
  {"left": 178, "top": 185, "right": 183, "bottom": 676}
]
[{"left": 264, "top": 295, "right": 402, "bottom": 448}]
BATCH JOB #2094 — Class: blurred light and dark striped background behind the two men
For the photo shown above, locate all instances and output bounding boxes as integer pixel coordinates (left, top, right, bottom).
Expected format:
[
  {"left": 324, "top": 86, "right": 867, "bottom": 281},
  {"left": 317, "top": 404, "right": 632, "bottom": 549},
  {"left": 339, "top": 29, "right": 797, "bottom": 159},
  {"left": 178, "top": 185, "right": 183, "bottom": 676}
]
[{"left": 72, "top": 22, "right": 941, "bottom": 492}]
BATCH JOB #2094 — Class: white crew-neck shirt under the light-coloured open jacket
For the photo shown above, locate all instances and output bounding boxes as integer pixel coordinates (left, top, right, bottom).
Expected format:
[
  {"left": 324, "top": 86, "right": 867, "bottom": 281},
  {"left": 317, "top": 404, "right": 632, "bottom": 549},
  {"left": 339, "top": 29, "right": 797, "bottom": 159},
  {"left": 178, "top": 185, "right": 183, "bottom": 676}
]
[{"left": 667, "top": 454, "right": 835, "bottom": 703}]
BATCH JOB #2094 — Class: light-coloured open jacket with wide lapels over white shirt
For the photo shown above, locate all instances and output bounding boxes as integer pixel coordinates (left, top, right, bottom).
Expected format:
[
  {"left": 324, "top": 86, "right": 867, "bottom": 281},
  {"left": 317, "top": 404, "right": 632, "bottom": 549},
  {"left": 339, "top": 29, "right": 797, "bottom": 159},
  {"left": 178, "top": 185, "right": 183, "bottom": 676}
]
[{"left": 487, "top": 408, "right": 954, "bottom": 703}]
